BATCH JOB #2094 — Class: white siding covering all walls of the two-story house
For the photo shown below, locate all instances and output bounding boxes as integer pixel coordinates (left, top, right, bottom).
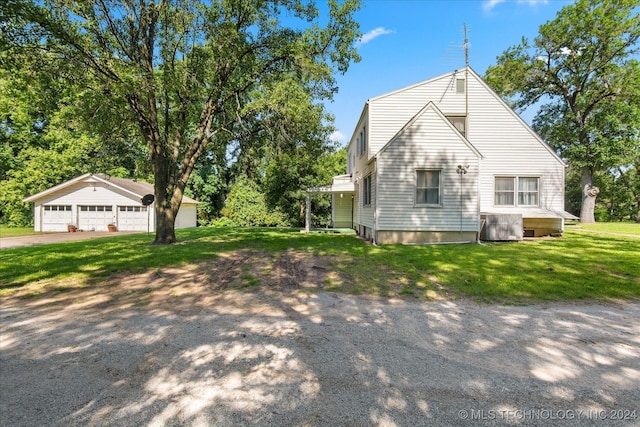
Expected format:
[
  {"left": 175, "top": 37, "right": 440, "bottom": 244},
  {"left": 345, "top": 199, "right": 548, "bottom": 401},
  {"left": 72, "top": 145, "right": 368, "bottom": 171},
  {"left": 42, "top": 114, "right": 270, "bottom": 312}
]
[{"left": 348, "top": 70, "right": 565, "bottom": 241}]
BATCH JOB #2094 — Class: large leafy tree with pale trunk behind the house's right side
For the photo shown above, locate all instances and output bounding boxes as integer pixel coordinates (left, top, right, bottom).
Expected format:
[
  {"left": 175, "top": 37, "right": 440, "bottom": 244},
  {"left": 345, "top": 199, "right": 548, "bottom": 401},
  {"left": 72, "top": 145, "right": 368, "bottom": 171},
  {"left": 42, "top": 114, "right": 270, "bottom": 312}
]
[{"left": 486, "top": 0, "right": 640, "bottom": 226}]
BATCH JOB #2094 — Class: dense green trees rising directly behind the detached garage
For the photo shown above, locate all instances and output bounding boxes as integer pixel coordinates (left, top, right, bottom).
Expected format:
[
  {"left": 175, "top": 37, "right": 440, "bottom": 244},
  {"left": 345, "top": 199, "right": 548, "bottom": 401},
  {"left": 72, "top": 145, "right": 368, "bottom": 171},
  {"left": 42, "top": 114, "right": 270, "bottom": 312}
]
[{"left": 0, "top": 46, "right": 150, "bottom": 226}]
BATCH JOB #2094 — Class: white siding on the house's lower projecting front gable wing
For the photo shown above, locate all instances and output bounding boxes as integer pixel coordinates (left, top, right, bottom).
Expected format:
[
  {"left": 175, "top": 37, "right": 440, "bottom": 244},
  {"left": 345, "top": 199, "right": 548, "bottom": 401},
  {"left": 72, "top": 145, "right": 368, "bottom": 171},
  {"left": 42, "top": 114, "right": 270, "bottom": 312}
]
[{"left": 376, "top": 107, "right": 479, "bottom": 231}]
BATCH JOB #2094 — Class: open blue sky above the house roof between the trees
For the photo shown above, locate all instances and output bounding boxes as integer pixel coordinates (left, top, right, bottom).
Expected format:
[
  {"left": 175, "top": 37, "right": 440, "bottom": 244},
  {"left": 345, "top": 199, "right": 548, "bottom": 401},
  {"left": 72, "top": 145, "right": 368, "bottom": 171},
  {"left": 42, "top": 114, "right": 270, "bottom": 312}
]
[{"left": 326, "top": 0, "right": 573, "bottom": 144}]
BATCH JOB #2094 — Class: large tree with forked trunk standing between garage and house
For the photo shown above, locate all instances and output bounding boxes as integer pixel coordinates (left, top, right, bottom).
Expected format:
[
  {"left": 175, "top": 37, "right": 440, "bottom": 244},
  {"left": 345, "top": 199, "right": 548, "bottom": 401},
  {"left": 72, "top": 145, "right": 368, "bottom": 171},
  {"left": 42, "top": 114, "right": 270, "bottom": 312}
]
[{"left": 7, "top": 0, "right": 359, "bottom": 244}]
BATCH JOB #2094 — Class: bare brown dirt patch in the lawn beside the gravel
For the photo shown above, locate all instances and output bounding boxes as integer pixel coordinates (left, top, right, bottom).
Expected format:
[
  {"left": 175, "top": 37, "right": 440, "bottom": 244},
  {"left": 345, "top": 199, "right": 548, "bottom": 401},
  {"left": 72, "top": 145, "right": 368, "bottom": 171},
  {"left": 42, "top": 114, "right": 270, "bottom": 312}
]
[{"left": 0, "top": 250, "right": 350, "bottom": 313}]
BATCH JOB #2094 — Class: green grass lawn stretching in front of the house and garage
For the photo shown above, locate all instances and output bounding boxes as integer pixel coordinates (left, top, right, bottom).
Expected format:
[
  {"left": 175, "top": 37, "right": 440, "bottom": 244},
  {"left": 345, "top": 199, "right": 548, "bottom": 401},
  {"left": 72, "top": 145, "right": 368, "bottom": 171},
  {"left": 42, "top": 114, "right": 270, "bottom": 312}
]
[{"left": 0, "top": 228, "right": 640, "bottom": 304}]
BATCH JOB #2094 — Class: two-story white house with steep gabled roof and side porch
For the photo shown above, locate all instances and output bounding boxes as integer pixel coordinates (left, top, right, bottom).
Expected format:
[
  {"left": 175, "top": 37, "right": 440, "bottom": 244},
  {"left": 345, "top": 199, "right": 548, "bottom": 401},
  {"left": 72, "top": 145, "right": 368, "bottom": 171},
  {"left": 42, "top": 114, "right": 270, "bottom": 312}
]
[{"left": 309, "top": 67, "right": 575, "bottom": 244}]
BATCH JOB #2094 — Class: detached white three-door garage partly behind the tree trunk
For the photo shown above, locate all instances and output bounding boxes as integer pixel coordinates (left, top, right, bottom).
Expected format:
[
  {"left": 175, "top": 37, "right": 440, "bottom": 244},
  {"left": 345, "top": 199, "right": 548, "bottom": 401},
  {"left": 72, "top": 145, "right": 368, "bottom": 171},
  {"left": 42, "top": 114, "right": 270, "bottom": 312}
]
[{"left": 24, "top": 174, "right": 198, "bottom": 231}]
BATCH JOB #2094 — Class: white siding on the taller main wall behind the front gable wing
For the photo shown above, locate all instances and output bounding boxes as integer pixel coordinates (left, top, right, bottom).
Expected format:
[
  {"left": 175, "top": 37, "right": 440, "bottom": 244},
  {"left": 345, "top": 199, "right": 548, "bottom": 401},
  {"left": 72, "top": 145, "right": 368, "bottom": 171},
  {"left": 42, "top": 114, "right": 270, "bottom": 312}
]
[{"left": 366, "top": 71, "right": 565, "bottom": 217}]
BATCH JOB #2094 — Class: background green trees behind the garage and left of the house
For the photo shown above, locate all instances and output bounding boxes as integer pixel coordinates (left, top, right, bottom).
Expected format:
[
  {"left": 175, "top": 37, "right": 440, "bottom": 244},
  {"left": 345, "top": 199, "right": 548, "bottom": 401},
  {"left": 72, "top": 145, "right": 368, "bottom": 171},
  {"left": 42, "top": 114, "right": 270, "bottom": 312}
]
[{"left": 0, "top": 58, "right": 346, "bottom": 226}]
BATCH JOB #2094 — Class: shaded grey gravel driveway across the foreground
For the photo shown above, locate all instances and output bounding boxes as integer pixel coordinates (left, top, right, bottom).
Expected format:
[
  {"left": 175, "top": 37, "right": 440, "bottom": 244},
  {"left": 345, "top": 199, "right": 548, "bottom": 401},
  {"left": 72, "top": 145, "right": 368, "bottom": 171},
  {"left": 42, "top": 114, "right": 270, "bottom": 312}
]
[{"left": 0, "top": 291, "right": 640, "bottom": 426}]
